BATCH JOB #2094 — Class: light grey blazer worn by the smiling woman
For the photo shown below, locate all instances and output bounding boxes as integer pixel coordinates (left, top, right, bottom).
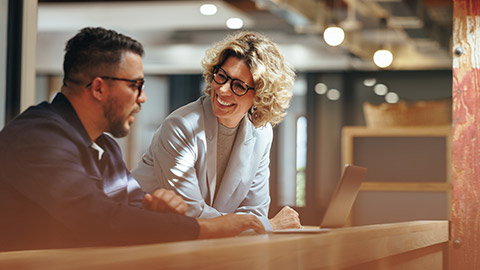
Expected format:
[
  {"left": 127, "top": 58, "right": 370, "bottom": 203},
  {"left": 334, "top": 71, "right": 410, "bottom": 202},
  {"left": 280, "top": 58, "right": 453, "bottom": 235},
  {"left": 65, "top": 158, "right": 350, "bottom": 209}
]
[{"left": 132, "top": 96, "right": 273, "bottom": 230}]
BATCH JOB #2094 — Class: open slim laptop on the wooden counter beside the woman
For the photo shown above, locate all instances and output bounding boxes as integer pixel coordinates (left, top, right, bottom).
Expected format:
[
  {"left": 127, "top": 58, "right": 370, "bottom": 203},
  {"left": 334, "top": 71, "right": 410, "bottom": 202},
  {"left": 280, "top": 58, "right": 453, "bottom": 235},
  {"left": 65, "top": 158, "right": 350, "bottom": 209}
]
[{"left": 272, "top": 164, "right": 367, "bottom": 233}]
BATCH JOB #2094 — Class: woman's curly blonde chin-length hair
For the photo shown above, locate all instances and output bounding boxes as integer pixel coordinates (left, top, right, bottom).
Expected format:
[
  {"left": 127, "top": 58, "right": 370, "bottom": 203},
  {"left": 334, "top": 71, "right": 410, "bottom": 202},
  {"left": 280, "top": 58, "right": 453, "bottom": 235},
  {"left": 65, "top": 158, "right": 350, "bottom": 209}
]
[{"left": 202, "top": 31, "right": 295, "bottom": 127}]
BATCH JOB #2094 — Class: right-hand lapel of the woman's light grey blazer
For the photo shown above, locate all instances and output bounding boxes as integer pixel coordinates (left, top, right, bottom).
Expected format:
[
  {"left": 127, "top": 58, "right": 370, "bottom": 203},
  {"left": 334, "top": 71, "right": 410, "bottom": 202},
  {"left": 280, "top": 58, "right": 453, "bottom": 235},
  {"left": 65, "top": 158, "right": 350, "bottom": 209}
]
[{"left": 213, "top": 116, "right": 255, "bottom": 211}]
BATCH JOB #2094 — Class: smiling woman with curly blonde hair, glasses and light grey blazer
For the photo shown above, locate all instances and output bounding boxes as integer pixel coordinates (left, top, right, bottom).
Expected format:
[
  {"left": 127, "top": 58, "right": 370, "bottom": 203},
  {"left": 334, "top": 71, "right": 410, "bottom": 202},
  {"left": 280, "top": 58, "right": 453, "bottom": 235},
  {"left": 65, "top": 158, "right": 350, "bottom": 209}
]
[{"left": 133, "top": 32, "right": 300, "bottom": 230}]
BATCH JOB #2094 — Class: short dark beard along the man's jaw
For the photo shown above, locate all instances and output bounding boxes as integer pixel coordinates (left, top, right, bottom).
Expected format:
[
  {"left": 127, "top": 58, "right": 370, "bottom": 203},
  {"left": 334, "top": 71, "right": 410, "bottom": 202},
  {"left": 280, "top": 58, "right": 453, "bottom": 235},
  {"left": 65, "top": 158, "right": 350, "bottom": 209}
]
[{"left": 103, "top": 97, "right": 140, "bottom": 138}]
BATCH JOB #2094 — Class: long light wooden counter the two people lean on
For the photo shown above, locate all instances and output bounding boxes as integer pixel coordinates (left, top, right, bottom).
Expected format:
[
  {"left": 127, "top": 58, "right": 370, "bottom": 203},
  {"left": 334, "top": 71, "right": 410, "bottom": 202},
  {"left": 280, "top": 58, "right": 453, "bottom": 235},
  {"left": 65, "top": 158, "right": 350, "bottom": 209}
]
[{"left": 0, "top": 221, "right": 449, "bottom": 270}]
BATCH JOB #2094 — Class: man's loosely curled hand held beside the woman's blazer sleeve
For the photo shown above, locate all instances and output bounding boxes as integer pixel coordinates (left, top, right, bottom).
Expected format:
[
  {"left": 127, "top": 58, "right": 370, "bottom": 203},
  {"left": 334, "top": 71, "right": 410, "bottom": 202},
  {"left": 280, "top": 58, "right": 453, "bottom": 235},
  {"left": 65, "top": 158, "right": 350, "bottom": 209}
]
[{"left": 142, "top": 189, "right": 187, "bottom": 215}]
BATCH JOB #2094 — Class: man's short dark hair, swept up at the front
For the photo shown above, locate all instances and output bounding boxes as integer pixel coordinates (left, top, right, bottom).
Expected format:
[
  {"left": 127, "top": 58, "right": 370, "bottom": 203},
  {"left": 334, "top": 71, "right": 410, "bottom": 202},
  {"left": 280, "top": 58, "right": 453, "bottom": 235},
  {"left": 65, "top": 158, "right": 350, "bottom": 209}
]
[{"left": 63, "top": 27, "right": 144, "bottom": 85}]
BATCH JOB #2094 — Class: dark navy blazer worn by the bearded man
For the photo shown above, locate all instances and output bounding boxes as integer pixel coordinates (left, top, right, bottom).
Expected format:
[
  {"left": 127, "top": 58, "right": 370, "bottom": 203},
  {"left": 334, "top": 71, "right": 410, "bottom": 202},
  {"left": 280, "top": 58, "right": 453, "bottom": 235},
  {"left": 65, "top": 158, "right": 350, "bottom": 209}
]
[{"left": 0, "top": 93, "right": 199, "bottom": 251}]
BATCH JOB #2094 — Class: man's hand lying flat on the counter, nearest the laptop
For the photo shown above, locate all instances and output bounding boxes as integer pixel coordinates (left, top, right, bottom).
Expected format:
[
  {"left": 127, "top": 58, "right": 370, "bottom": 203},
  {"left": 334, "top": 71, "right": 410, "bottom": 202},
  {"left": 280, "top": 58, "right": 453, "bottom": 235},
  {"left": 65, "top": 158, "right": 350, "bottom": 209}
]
[{"left": 197, "top": 214, "right": 265, "bottom": 239}]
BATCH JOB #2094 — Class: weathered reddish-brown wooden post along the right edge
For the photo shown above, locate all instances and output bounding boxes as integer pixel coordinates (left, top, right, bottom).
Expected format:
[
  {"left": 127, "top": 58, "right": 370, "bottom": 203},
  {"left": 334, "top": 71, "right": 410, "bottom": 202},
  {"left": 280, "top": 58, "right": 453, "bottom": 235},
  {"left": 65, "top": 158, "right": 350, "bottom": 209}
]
[{"left": 450, "top": 0, "right": 480, "bottom": 269}]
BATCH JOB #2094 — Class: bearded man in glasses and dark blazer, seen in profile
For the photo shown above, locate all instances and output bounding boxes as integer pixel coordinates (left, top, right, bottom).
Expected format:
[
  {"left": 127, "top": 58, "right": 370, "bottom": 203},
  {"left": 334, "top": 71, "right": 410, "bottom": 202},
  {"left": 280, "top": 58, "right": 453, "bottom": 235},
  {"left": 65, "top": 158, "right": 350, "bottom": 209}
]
[{"left": 0, "top": 28, "right": 264, "bottom": 250}]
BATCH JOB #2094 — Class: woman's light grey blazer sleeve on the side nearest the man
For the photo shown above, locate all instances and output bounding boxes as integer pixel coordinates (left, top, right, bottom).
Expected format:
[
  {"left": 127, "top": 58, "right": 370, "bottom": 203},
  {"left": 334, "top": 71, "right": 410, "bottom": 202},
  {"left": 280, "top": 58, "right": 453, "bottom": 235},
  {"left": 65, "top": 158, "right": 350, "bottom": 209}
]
[{"left": 133, "top": 115, "right": 225, "bottom": 218}]
